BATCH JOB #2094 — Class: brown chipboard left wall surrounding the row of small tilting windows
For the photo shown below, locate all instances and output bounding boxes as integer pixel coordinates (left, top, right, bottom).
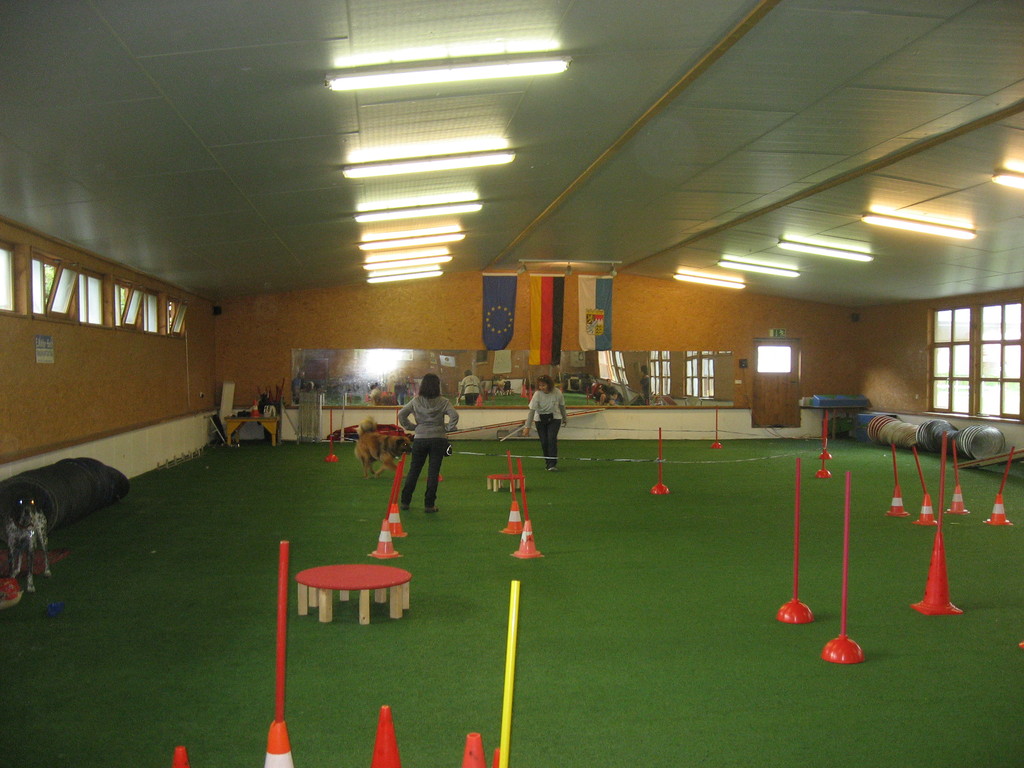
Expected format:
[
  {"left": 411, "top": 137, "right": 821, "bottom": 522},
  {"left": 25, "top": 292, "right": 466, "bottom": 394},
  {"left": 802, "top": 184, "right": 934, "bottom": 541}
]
[{"left": 0, "top": 220, "right": 216, "bottom": 465}]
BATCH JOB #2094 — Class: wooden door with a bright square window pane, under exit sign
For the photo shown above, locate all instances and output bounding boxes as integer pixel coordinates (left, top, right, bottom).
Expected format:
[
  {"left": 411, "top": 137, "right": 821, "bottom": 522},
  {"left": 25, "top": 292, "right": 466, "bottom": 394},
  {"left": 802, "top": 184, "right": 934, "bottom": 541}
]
[{"left": 751, "top": 339, "right": 800, "bottom": 427}]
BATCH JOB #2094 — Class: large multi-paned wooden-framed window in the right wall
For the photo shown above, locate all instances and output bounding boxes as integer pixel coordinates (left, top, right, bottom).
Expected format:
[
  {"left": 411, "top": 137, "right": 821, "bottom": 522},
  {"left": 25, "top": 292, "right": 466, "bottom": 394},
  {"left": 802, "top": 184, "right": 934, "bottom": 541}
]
[{"left": 931, "top": 302, "right": 1021, "bottom": 419}]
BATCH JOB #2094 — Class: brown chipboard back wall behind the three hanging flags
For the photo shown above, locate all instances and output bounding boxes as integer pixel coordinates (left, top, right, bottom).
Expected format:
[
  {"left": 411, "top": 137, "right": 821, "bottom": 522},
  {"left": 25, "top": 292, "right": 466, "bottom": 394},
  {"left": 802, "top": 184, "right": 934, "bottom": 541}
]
[{"left": 216, "top": 273, "right": 861, "bottom": 408}]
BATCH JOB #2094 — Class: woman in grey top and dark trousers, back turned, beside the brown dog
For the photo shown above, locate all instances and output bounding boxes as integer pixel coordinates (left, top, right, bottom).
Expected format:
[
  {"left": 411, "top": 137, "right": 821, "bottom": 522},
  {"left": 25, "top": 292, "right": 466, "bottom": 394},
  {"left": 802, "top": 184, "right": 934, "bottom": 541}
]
[{"left": 398, "top": 374, "right": 459, "bottom": 512}]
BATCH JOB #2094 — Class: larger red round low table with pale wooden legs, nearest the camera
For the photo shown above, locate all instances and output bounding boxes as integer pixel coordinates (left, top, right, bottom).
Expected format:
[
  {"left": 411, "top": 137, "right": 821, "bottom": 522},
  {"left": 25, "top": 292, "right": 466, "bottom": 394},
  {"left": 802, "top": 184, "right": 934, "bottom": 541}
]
[{"left": 295, "top": 565, "right": 413, "bottom": 624}]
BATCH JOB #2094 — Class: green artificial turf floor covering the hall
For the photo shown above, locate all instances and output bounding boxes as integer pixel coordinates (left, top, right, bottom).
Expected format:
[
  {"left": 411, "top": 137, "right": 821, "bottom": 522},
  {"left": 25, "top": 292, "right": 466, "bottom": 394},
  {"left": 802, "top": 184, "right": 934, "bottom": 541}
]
[{"left": 6, "top": 440, "right": 1024, "bottom": 768}]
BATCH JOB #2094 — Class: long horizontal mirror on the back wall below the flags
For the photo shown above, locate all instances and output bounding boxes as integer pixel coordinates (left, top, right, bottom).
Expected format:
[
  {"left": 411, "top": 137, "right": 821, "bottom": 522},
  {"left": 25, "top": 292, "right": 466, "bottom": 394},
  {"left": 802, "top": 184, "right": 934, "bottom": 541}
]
[{"left": 291, "top": 349, "right": 733, "bottom": 408}]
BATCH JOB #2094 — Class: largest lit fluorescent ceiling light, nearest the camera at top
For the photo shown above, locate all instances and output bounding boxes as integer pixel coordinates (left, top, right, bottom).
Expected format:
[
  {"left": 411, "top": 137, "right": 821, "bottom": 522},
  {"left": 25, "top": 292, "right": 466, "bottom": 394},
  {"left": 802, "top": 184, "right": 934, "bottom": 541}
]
[{"left": 327, "top": 56, "right": 572, "bottom": 91}]
